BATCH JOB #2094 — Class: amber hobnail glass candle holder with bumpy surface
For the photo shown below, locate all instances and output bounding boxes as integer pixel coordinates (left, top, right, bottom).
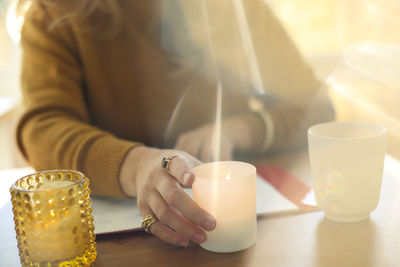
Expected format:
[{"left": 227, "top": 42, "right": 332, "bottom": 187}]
[{"left": 10, "top": 170, "right": 97, "bottom": 266}]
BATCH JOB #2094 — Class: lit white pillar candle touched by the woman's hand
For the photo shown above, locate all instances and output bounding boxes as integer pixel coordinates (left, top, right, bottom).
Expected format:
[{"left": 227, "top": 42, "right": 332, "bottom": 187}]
[{"left": 193, "top": 161, "right": 257, "bottom": 252}]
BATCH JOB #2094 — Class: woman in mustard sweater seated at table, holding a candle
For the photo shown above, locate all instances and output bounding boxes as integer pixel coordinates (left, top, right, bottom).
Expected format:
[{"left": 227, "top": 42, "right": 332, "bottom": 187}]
[{"left": 17, "top": 0, "right": 332, "bottom": 247}]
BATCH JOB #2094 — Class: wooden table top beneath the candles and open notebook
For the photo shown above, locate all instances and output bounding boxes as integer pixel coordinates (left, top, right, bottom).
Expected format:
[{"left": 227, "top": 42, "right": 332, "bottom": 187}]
[{"left": 0, "top": 152, "right": 400, "bottom": 267}]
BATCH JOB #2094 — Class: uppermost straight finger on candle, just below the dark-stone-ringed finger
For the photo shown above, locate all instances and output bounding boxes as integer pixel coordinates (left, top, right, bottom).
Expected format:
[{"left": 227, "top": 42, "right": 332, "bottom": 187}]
[{"left": 156, "top": 177, "right": 216, "bottom": 231}]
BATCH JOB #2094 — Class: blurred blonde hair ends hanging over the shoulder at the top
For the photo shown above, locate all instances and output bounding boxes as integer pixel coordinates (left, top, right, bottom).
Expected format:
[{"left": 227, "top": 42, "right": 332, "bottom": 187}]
[{"left": 17, "top": 0, "right": 122, "bottom": 39}]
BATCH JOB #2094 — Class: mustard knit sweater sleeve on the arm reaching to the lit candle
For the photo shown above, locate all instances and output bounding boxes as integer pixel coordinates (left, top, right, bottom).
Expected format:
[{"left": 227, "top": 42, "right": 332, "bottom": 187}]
[{"left": 16, "top": 1, "right": 139, "bottom": 197}]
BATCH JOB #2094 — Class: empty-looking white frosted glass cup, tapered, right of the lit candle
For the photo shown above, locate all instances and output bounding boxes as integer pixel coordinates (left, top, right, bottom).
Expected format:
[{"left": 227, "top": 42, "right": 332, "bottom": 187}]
[{"left": 308, "top": 122, "right": 386, "bottom": 222}]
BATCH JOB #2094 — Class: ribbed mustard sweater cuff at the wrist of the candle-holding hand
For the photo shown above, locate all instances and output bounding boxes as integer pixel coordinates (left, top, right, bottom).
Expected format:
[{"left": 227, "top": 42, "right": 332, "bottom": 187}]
[{"left": 84, "top": 137, "right": 141, "bottom": 198}]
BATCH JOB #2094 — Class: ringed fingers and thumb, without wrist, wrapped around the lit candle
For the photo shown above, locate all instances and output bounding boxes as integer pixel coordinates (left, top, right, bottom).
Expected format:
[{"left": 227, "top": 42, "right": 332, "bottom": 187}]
[{"left": 138, "top": 150, "right": 216, "bottom": 246}]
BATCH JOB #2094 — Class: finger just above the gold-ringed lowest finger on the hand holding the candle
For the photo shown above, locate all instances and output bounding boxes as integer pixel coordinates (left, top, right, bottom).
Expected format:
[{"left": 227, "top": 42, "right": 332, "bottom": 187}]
[{"left": 149, "top": 194, "right": 206, "bottom": 243}]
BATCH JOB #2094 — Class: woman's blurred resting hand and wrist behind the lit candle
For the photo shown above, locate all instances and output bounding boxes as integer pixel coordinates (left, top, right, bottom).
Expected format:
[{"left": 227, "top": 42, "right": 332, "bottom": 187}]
[{"left": 175, "top": 114, "right": 264, "bottom": 162}]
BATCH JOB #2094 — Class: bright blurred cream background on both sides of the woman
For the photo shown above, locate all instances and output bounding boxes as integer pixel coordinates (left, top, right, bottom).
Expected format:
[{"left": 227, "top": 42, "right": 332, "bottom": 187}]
[{"left": 0, "top": 0, "right": 400, "bottom": 168}]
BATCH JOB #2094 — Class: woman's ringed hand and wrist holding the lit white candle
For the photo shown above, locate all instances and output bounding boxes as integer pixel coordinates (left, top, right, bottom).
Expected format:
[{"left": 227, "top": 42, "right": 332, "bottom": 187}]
[{"left": 120, "top": 147, "right": 216, "bottom": 247}]
